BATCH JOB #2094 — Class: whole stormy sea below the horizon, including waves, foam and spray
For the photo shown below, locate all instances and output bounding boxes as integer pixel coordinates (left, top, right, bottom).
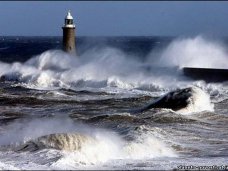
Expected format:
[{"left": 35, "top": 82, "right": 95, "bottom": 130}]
[{"left": 0, "top": 36, "right": 228, "bottom": 170}]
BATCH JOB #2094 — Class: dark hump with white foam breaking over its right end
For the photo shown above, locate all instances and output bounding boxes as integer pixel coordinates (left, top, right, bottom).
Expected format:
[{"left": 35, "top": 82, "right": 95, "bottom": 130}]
[{"left": 132, "top": 87, "right": 214, "bottom": 114}]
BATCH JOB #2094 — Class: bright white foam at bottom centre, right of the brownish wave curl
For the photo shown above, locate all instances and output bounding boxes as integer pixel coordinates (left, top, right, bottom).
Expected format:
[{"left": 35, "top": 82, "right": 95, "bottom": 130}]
[{"left": 52, "top": 132, "right": 177, "bottom": 168}]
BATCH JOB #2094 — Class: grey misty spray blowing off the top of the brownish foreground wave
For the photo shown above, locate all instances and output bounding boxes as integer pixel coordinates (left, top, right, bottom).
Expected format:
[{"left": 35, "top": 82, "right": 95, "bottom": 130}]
[{"left": 0, "top": 117, "right": 88, "bottom": 145}]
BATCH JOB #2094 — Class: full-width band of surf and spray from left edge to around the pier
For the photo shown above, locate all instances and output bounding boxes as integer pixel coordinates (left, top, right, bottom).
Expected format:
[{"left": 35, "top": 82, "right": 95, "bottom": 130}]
[{"left": 0, "top": 36, "right": 228, "bottom": 100}]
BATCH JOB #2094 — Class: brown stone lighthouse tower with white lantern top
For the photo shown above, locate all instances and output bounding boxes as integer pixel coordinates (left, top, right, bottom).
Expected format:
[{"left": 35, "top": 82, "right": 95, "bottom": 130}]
[{"left": 62, "top": 10, "right": 76, "bottom": 54}]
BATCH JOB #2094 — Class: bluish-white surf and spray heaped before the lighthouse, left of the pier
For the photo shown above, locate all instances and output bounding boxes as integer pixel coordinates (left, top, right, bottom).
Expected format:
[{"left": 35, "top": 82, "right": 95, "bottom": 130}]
[{"left": 1, "top": 48, "right": 180, "bottom": 89}]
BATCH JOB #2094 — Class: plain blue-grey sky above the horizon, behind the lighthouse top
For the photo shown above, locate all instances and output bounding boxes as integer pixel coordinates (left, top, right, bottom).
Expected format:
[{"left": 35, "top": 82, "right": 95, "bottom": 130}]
[{"left": 0, "top": 1, "right": 228, "bottom": 36}]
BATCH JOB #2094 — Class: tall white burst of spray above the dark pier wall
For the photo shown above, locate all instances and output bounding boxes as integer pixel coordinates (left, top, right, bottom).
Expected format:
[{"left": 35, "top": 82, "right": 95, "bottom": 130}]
[{"left": 148, "top": 36, "right": 228, "bottom": 69}]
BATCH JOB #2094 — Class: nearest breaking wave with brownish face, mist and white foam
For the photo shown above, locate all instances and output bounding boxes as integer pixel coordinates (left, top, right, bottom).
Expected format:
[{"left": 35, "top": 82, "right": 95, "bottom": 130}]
[{"left": 0, "top": 119, "right": 177, "bottom": 168}]
